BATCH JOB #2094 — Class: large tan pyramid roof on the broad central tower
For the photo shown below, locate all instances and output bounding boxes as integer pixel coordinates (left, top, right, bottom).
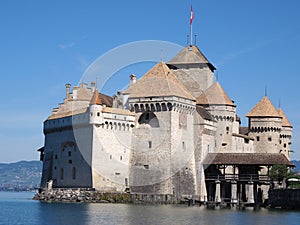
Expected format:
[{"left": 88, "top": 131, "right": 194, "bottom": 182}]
[{"left": 125, "top": 62, "right": 195, "bottom": 101}]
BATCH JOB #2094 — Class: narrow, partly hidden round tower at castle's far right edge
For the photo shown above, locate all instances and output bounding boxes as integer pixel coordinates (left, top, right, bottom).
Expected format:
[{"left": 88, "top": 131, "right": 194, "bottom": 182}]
[{"left": 278, "top": 108, "right": 293, "bottom": 160}]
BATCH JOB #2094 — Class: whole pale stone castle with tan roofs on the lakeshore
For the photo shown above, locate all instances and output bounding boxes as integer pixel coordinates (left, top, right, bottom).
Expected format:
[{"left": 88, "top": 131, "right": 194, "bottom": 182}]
[{"left": 39, "top": 46, "right": 292, "bottom": 203}]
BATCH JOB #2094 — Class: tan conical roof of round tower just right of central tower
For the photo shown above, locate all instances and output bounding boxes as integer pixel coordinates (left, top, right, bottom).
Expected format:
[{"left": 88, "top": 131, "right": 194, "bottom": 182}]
[{"left": 196, "top": 82, "right": 235, "bottom": 106}]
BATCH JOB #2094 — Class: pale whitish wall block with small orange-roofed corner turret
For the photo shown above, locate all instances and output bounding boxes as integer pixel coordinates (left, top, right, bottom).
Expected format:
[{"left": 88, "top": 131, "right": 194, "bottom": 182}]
[{"left": 88, "top": 90, "right": 135, "bottom": 192}]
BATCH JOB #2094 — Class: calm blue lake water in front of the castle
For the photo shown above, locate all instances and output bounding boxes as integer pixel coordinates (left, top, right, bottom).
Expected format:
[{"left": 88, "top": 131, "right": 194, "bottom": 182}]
[{"left": 0, "top": 192, "right": 300, "bottom": 225}]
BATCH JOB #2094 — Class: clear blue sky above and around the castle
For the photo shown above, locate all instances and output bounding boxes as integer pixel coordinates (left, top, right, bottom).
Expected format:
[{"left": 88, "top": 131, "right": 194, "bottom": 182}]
[{"left": 0, "top": 0, "right": 300, "bottom": 162}]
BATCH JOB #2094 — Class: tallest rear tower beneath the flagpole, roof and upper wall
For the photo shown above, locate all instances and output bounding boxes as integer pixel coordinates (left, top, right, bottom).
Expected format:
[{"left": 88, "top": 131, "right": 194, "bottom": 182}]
[{"left": 168, "top": 45, "right": 216, "bottom": 98}]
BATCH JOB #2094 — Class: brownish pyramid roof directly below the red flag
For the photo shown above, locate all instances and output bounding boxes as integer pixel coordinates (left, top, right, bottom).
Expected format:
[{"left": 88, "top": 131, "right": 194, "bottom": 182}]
[{"left": 168, "top": 45, "right": 216, "bottom": 71}]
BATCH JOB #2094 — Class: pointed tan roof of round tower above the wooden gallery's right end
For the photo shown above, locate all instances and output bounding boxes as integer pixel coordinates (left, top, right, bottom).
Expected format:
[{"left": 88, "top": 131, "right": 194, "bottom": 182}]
[{"left": 246, "top": 96, "right": 282, "bottom": 118}]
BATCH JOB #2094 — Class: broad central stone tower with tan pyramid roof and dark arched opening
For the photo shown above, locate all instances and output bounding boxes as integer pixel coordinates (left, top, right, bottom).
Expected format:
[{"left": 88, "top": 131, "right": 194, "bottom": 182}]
[{"left": 125, "top": 62, "right": 196, "bottom": 196}]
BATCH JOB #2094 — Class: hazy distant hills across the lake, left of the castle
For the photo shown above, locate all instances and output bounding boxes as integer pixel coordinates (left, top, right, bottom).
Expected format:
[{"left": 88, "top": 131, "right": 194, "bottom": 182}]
[{"left": 0, "top": 161, "right": 42, "bottom": 191}]
